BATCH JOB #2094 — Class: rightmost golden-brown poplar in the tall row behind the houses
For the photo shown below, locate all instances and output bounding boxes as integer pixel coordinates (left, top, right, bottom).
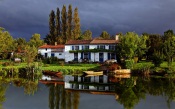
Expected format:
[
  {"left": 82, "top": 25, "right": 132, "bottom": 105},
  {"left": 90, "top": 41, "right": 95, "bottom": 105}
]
[{"left": 73, "top": 7, "right": 81, "bottom": 39}]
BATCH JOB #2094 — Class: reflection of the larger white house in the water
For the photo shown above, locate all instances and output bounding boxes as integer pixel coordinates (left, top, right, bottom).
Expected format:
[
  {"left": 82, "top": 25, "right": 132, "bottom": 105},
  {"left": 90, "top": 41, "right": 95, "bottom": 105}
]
[{"left": 64, "top": 75, "right": 114, "bottom": 91}]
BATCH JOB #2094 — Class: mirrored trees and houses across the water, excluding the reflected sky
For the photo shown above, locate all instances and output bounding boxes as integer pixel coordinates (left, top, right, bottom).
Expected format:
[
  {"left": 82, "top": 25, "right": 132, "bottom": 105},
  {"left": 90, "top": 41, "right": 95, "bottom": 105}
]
[{"left": 0, "top": 71, "right": 175, "bottom": 109}]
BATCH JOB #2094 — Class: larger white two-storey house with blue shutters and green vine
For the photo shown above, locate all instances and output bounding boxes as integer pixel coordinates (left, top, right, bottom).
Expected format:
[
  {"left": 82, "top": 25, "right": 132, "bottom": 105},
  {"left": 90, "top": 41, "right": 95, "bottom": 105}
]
[{"left": 65, "top": 36, "right": 118, "bottom": 62}]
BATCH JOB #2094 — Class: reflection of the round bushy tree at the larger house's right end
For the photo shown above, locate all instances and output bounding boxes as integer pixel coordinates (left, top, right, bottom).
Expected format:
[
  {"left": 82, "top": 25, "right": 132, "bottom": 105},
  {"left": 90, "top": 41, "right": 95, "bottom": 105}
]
[{"left": 116, "top": 78, "right": 145, "bottom": 109}]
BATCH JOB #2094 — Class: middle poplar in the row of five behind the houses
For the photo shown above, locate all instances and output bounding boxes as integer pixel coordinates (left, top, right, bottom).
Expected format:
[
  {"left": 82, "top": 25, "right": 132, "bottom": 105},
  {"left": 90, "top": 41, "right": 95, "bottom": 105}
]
[{"left": 61, "top": 5, "right": 67, "bottom": 43}]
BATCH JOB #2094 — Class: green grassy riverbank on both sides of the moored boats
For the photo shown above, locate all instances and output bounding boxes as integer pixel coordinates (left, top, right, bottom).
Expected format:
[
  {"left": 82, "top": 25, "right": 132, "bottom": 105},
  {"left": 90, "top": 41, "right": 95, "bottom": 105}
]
[{"left": 0, "top": 60, "right": 175, "bottom": 74}]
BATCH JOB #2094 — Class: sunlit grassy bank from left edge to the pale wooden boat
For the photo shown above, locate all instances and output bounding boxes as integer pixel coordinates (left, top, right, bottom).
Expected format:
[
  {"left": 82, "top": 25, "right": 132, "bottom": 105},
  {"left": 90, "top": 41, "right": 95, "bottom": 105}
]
[{"left": 0, "top": 60, "right": 100, "bottom": 74}]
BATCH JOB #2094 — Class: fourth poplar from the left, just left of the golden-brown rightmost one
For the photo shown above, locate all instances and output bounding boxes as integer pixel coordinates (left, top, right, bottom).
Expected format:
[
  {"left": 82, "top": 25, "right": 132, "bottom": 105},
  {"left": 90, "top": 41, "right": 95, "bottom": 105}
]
[{"left": 67, "top": 5, "right": 73, "bottom": 39}]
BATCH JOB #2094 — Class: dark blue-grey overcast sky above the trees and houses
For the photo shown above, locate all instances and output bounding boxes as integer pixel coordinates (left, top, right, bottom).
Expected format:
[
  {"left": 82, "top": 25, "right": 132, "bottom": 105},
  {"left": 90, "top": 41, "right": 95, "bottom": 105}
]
[{"left": 0, "top": 0, "right": 175, "bottom": 39}]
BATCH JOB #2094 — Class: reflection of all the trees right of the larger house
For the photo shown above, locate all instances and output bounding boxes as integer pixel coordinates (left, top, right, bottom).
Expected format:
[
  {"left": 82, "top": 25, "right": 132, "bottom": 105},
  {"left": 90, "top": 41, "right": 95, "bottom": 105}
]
[{"left": 116, "top": 77, "right": 175, "bottom": 109}]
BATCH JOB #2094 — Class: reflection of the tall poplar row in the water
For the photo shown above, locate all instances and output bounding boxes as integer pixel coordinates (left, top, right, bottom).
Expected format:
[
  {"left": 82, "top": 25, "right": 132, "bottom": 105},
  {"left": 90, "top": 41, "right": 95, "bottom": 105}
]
[{"left": 48, "top": 84, "right": 80, "bottom": 109}]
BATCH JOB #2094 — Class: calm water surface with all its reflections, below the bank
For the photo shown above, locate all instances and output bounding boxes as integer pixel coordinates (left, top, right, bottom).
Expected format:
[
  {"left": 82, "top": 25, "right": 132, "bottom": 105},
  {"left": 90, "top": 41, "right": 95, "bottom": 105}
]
[{"left": 0, "top": 75, "right": 175, "bottom": 109}]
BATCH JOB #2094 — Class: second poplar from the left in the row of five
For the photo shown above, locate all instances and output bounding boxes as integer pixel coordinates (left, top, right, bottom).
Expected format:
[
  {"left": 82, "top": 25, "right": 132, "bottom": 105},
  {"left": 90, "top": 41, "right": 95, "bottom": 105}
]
[{"left": 55, "top": 8, "right": 61, "bottom": 37}]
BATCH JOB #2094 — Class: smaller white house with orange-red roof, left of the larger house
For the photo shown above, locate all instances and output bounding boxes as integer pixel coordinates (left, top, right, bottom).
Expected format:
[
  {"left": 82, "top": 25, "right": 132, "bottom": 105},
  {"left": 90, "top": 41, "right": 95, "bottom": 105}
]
[{"left": 38, "top": 44, "right": 65, "bottom": 59}]
